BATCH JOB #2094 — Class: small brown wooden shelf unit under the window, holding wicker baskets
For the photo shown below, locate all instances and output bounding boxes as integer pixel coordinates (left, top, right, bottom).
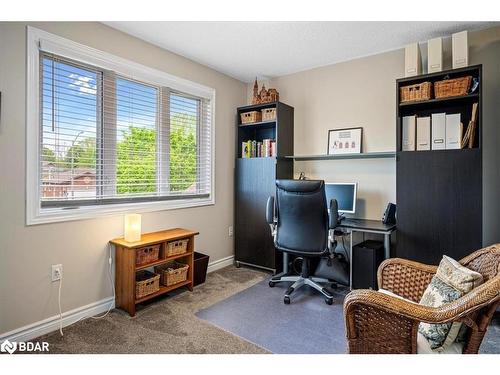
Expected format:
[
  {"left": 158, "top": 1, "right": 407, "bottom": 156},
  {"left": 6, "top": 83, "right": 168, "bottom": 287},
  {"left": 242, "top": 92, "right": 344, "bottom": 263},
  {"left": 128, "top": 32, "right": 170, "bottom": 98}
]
[{"left": 110, "top": 228, "right": 199, "bottom": 316}]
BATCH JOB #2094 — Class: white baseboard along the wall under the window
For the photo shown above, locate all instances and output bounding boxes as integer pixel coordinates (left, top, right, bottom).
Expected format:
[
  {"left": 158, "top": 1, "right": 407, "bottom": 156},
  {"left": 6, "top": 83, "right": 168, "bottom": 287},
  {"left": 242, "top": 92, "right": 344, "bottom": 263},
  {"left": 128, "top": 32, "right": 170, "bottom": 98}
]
[{"left": 0, "top": 255, "right": 234, "bottom": 342}]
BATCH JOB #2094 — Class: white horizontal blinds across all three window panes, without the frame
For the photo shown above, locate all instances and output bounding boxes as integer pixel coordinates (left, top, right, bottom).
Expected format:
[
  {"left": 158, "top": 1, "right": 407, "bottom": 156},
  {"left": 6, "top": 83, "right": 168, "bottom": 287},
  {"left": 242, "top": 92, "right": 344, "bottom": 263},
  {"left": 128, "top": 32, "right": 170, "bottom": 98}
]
[{"left": 40, "top": 52, "right": 212, "bottom": 208}]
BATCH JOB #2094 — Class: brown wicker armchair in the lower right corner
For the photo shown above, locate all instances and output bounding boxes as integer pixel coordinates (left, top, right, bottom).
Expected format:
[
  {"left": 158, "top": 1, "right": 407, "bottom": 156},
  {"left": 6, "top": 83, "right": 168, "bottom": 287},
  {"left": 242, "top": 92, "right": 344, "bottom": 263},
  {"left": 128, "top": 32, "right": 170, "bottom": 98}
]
[{"left": 344, "top": 244, "right": 500, "bottom": 354}]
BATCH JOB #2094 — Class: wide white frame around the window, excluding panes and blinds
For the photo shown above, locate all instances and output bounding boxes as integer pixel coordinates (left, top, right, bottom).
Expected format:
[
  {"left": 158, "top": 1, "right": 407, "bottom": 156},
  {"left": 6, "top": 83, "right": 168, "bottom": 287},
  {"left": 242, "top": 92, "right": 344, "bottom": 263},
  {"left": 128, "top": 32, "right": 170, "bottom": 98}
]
[{"left": 26, "top": 26, "right": 215, "bottom": 225}]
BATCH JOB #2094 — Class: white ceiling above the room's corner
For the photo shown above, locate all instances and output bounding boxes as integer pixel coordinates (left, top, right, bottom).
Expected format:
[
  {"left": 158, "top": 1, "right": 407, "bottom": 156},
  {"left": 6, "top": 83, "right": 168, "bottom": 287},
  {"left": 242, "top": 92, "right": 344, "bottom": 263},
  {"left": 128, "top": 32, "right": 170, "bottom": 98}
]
[{"left": 105, "top": 21, "right": 500, "bottom": 82}]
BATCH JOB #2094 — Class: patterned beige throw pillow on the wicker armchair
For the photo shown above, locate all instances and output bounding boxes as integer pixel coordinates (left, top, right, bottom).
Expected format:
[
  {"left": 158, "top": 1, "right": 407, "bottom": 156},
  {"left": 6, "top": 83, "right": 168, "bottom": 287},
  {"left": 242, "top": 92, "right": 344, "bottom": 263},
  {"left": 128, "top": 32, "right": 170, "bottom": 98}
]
[{"left": 418, "top": 255, "right": 483, "bottom": 352}]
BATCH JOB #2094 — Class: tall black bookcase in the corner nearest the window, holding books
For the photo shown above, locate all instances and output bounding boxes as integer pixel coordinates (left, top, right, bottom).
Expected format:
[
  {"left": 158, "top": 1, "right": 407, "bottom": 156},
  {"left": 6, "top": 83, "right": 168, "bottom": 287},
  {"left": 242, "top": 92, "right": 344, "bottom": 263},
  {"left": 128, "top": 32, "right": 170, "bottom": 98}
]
[{"left": 234, "top": 102, "right": 294, "bottom": 272}]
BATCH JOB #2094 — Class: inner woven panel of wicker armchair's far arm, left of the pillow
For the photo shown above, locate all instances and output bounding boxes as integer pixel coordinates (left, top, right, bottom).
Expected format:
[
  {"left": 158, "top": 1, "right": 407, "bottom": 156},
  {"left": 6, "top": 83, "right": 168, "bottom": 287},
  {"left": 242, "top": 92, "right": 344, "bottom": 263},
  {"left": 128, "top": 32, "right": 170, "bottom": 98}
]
[{"left": 377, "top": 258, "right": 437, "bottom": 303}]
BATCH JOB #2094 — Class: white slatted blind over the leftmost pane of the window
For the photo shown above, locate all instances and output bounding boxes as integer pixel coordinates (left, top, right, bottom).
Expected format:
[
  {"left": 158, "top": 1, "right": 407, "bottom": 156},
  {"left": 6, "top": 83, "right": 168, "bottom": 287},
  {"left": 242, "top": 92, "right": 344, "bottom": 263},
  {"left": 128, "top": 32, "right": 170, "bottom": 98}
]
[{"left": 40, "top": 55, "right": 101, "bottom": 201}]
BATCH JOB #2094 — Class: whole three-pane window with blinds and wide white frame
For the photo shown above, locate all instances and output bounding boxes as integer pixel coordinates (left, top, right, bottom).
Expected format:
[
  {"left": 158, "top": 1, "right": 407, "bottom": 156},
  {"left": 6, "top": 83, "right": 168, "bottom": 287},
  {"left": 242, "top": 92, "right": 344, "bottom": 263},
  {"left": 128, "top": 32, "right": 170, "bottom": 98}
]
[{"left": 27, "top": 28, "right": 215, "bottom": 224}]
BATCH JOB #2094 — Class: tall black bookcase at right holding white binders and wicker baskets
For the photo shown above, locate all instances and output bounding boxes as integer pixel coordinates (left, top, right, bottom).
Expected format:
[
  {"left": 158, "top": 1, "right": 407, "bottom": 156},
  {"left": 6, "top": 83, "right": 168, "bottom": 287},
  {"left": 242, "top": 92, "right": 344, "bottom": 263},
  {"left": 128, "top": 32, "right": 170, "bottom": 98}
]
[{"left": 393, "top": 65, "right": 483, "bottom": 264}]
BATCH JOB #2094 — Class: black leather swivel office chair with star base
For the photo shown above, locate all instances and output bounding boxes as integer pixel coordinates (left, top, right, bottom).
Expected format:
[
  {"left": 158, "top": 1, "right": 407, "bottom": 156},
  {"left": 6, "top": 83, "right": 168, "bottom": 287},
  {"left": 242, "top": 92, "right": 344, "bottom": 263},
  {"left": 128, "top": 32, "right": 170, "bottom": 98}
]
[{"left": 266, "top": 180, "right": 338, "bottom": 305}]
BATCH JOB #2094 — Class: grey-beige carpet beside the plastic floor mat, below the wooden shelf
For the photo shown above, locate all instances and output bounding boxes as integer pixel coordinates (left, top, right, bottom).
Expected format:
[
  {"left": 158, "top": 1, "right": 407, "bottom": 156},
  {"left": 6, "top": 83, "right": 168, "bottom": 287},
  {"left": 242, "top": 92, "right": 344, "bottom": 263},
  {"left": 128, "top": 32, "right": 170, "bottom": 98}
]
[{"left": 36, "top": 266, "right": 268, "bottom": 354}]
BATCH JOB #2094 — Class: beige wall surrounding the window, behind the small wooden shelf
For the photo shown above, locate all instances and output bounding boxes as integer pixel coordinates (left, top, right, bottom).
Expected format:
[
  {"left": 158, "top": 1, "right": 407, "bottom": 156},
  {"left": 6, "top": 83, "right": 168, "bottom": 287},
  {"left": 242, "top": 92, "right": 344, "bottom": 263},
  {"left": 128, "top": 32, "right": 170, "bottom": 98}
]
[{"left": 0, "top": 22, "right": 246, "bottom": 335}]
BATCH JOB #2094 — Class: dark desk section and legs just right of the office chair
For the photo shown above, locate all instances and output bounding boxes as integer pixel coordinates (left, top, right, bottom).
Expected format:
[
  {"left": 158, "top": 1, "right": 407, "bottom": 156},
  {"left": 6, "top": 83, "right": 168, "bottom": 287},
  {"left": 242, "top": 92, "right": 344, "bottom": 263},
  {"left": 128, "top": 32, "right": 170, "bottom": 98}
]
[{"left": 337, "top": 218, "right": 396, "bottom": 287}]
